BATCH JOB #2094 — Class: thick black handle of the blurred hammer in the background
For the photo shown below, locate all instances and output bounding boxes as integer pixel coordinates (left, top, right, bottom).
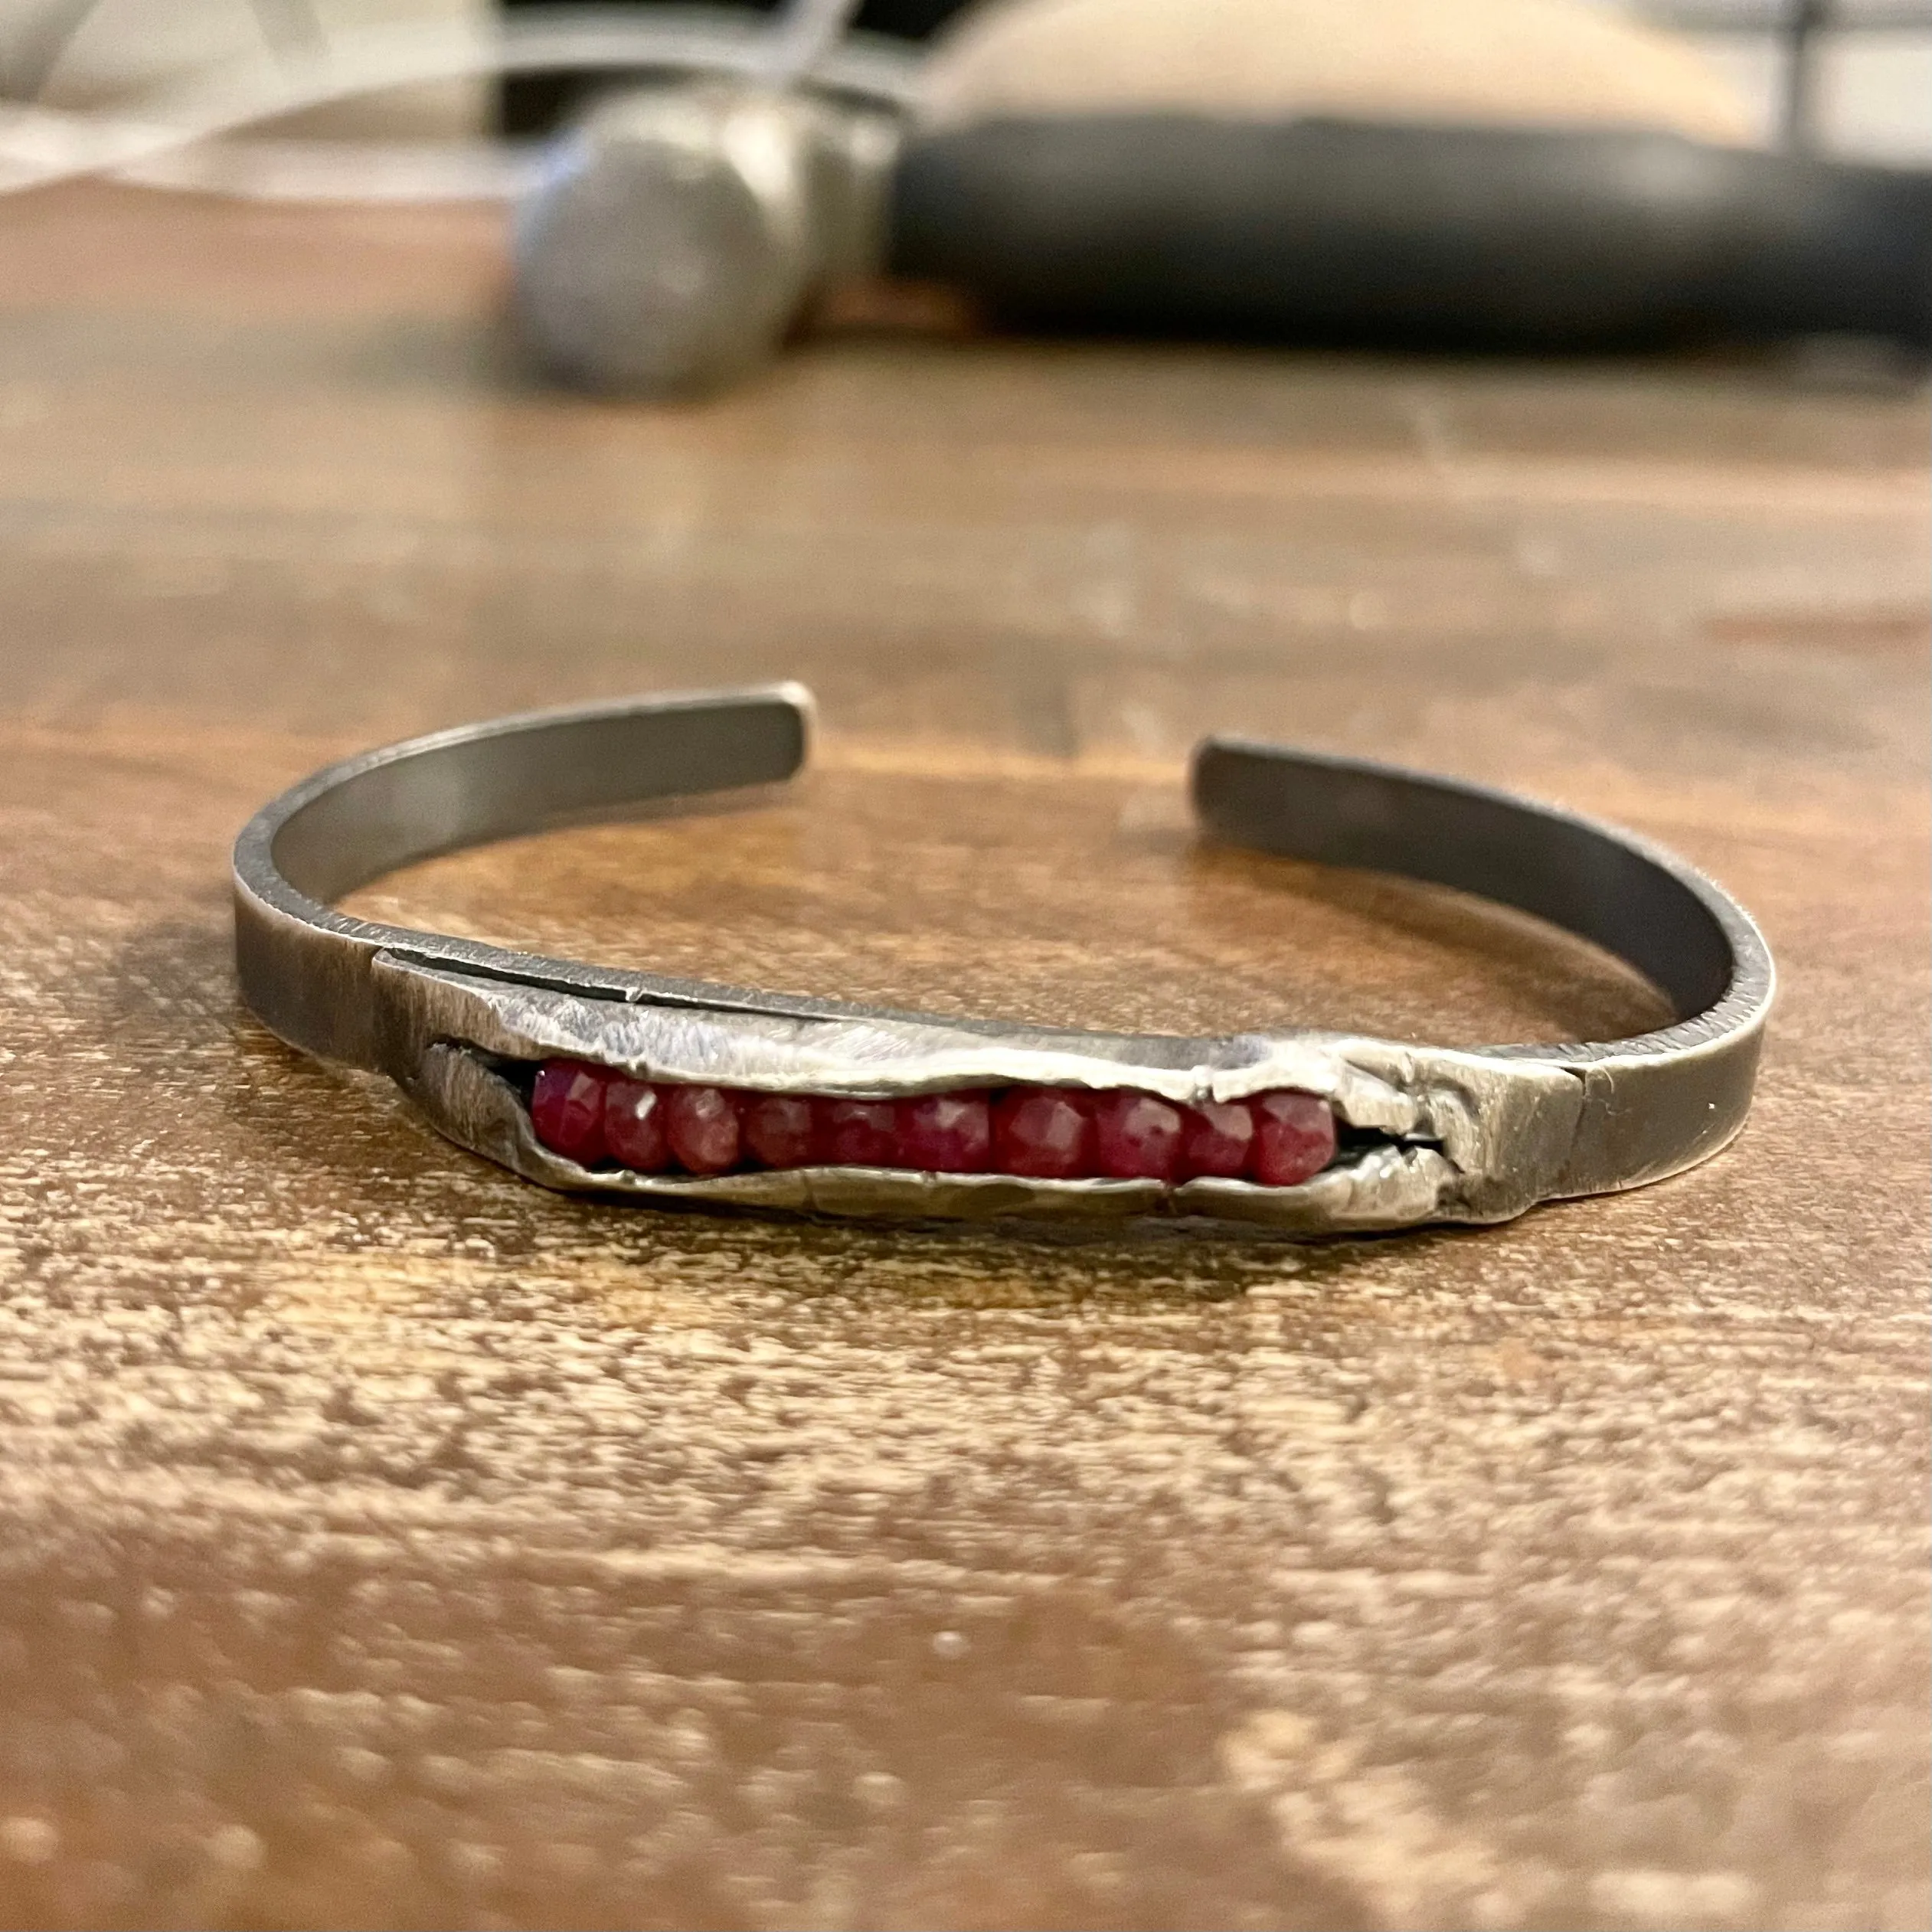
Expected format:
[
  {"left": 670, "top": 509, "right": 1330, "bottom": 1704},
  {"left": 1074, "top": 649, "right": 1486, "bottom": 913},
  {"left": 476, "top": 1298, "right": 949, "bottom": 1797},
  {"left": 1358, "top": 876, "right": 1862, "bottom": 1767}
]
[{"left": 889, "top": 114, "right": 1932, "bottom": 348}]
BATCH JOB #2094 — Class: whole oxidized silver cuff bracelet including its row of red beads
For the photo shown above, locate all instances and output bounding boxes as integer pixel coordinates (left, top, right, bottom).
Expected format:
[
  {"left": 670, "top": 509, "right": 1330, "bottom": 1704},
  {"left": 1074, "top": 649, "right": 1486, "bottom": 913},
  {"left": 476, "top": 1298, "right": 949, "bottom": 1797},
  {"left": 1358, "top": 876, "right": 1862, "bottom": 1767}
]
[{"left": 234, "top": 686, "right": 1772, "bottom": 1233}]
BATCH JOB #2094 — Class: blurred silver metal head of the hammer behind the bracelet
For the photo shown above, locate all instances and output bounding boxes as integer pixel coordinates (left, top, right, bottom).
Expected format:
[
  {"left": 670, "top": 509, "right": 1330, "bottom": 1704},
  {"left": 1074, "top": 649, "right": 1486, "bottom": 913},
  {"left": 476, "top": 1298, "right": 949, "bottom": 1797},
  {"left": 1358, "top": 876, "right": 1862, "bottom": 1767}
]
[{"left": 514, "top": 81, "right": 898, "bottom": 394}]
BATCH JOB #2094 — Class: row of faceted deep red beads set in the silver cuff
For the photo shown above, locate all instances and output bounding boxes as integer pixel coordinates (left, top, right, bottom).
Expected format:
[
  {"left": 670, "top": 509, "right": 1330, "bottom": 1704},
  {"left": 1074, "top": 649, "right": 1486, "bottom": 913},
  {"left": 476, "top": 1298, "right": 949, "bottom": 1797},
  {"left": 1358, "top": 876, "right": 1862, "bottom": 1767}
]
[{"left": 529, "top": 1061, "right": 1335, "bottom": 1188}]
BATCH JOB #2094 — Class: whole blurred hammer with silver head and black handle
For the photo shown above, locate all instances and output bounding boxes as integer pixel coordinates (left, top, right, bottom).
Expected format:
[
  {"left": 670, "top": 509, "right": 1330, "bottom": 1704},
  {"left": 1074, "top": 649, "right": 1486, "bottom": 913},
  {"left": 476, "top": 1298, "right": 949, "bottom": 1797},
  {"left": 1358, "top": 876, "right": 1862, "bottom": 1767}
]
[{"left": 516, "top": 81, "right": 1932, "bottom": 394}]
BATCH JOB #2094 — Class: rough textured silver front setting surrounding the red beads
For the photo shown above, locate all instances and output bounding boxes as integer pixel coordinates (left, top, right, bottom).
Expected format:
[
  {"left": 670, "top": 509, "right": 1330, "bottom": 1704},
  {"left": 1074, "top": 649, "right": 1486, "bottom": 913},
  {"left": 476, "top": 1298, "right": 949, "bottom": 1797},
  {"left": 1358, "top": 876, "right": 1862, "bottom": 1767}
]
[{"left": 388, "top": 956, "right": 1582, "bottom": 1233}]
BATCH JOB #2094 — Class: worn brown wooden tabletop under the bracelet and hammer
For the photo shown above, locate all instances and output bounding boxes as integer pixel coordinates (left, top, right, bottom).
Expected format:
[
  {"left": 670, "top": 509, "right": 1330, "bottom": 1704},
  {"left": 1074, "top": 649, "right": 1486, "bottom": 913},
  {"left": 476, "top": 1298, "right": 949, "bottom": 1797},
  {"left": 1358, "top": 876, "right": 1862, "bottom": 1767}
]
[{"left": 0, "top": 189, "right": 1928, "bottom": 1932}]
